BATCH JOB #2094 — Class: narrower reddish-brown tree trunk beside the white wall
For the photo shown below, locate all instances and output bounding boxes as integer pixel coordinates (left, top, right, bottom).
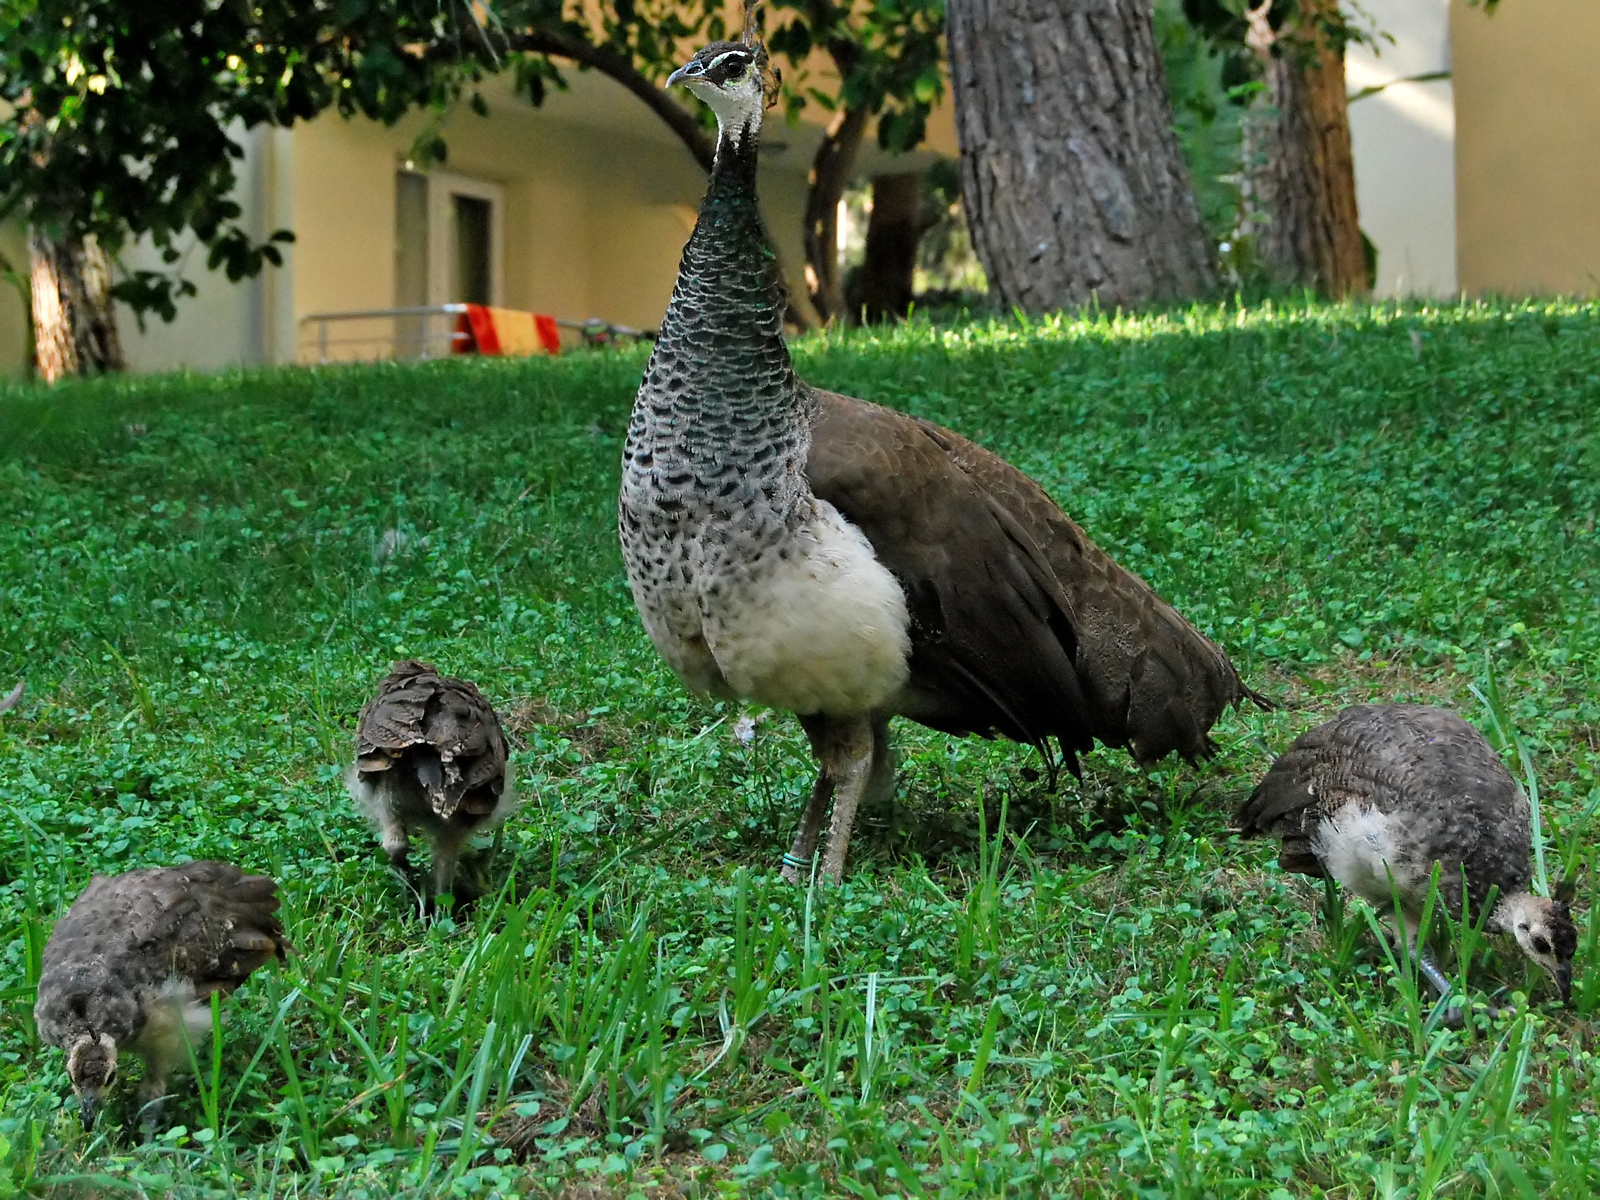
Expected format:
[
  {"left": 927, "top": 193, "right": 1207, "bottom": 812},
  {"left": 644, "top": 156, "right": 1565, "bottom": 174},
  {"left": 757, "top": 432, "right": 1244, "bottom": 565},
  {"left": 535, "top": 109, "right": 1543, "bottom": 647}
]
[{"left": 1248, "top": 0, "right": 1371, "bottom": 298}]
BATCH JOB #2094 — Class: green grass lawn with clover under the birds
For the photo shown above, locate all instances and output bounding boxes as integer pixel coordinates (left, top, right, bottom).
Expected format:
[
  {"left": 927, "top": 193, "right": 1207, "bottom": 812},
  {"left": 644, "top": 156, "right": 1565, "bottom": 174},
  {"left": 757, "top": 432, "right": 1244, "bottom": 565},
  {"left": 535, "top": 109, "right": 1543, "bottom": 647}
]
[{"left": 0, "top": 296, "right": 1600, "bottom": 1197}]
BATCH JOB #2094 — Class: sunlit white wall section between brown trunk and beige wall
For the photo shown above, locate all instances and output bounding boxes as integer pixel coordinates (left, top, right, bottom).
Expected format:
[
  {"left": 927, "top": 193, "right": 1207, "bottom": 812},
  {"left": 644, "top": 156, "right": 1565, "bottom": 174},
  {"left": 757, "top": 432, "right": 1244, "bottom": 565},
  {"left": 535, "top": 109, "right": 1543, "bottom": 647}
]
[{"left": 1344, "top": 0, "right": 1458, "bottom": 296}]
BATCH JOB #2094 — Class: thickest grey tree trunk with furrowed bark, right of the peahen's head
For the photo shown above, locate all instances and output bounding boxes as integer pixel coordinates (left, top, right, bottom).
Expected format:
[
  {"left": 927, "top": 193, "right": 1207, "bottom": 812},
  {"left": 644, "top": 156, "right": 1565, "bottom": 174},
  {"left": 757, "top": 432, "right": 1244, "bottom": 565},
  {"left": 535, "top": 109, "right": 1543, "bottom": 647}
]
[{"left": 949, "top": 0, "right": 1218, "bottom": 312}]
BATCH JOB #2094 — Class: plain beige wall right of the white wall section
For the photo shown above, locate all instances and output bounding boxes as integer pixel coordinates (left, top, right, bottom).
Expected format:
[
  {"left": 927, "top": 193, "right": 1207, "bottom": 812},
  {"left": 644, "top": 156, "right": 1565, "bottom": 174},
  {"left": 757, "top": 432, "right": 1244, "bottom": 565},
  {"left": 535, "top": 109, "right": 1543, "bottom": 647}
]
[{"left": 1450, "top": 0, "right": 1600, "bottom": 296}]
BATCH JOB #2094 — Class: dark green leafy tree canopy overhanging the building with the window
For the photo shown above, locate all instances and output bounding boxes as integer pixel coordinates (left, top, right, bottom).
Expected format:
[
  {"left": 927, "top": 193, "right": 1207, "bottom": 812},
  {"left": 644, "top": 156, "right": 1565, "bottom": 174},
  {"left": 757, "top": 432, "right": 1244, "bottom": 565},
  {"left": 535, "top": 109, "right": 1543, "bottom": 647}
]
[{"left": 0, "top": 0, "right": 944, "bottom": 339}]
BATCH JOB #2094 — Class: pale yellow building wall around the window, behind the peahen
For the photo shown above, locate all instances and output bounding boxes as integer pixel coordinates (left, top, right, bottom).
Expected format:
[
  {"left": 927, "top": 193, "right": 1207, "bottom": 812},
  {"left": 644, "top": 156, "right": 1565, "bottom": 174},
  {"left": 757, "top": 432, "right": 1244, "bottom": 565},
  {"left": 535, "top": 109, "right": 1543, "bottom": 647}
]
[{"left": 0, "top": 52, "right": 955, "bottom": 374}]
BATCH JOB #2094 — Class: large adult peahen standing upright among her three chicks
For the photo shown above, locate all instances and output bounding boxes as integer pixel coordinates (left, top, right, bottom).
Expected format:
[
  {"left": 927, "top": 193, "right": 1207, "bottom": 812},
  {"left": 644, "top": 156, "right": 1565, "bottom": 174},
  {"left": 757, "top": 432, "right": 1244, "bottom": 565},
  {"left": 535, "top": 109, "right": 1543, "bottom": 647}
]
[{"left": 619, "top": 34, "right": 1259, "bottom": 880}]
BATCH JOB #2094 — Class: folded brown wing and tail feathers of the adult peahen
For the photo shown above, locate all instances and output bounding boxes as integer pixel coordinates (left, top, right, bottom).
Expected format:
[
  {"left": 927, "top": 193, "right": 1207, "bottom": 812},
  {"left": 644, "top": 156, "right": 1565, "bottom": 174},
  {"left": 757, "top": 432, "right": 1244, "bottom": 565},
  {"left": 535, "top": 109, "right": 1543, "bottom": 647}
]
[{"left": 806, "top": 392, "right": 1259, "bottom": 768}]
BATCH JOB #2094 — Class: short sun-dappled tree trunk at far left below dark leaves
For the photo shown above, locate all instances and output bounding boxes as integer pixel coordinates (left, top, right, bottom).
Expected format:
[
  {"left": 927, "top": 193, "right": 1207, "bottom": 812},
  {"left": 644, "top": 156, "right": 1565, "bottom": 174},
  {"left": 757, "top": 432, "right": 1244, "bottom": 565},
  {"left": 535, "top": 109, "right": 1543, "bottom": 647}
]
[{"left": 27, "top": 229, "right": 126, "bottom": 384}]
